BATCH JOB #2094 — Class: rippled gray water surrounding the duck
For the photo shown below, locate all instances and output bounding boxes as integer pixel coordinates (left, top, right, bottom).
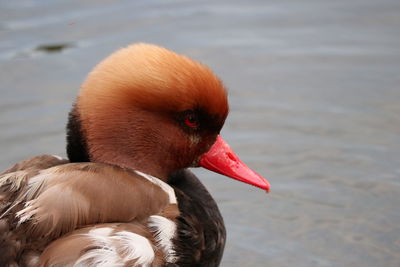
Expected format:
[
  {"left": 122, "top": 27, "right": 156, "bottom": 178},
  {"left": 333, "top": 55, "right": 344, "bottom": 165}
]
[{"left": 0, "top": 0, "right": 400, "bottom": 266}]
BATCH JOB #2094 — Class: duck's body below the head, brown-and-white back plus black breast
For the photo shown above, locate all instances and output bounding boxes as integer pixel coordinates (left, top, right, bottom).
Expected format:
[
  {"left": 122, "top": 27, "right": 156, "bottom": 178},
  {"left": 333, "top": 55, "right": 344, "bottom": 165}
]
[{"left": 0, "top": 155, "right": 225, "bottom": 266}]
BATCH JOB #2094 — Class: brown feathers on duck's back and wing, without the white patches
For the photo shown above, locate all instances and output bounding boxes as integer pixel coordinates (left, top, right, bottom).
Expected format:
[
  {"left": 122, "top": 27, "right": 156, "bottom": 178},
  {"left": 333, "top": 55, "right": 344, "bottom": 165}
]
[{"left": 0, "top": 155, "right": 179, "bottom": 266}]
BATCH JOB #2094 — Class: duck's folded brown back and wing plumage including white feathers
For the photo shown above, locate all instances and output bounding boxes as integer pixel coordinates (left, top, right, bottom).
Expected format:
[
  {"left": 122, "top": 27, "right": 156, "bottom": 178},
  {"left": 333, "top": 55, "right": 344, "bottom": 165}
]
[{"left": 0, "top": 156, "right": 179, "bottom": 266}]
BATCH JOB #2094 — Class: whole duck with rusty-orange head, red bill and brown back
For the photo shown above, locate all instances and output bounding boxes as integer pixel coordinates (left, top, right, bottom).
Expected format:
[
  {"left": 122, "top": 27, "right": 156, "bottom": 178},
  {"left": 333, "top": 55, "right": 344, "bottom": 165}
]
[{"left": 0, "top": 43, "right": 270, "bottom": 266}]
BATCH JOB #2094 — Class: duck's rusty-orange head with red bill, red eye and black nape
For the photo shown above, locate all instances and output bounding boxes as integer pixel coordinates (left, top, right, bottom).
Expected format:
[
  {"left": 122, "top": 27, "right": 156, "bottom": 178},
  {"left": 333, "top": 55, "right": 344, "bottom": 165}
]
[{"left": 67, "top": 44, "right": 269, "bottom": 191}]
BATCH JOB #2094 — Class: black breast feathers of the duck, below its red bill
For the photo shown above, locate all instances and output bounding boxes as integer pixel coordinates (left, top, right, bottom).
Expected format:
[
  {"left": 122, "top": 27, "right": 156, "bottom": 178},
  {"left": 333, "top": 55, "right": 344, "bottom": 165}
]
[{"left": 168, "top": 170, "right": 226, "bottom": 266}]
